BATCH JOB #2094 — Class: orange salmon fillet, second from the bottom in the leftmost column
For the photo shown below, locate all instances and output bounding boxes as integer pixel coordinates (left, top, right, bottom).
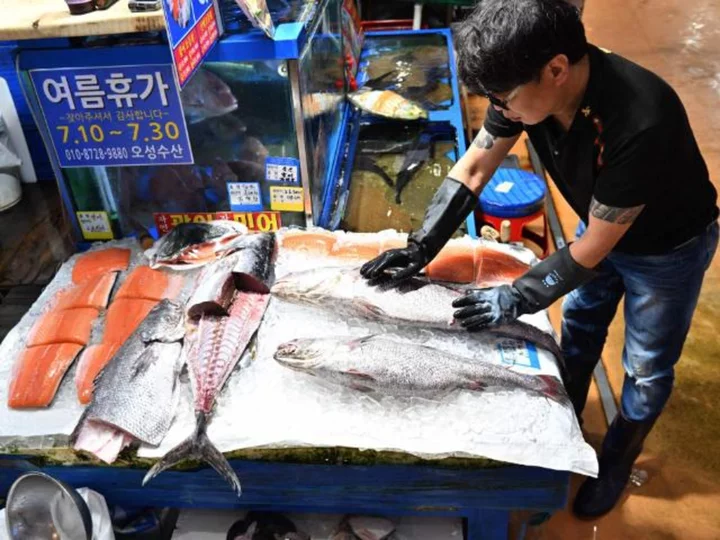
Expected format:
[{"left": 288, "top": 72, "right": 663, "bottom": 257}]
[{"left": 27, "top": 308, "right": 98, "bottom": 347}]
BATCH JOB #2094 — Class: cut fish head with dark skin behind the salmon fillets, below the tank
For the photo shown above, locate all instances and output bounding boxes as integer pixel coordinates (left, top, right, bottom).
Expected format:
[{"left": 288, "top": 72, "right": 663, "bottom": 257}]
[{"left": 150, "top": 220, "right": 248, "bottom": 268}]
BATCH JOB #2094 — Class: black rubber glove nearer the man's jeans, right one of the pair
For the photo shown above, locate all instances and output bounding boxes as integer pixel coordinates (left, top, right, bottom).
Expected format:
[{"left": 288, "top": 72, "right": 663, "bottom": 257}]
[{"left": 453, "top": 247, "right": 595, "bottom": 331}]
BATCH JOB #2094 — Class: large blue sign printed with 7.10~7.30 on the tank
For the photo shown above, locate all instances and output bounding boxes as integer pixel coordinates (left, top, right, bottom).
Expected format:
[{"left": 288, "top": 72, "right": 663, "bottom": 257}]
[{"left": 30, "top": 64, "right": 193, "bottom": 167}]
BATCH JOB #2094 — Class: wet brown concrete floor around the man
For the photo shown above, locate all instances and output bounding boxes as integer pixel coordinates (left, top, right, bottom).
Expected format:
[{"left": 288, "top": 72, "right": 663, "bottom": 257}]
[{"left": 531, "top": 0, "right": 720, "bottom": 540}]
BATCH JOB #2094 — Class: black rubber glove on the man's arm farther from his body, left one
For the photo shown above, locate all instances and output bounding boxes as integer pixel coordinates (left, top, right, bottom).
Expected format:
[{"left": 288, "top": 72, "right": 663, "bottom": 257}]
[{"left": 360, "top": 178, "right": 478, "bottom": 281}]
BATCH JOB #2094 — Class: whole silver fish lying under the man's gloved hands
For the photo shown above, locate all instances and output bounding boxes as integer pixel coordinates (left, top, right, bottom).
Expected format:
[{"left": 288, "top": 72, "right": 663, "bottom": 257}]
[{"left": 272, "top": 267, "right": 562, "bottom": 362}]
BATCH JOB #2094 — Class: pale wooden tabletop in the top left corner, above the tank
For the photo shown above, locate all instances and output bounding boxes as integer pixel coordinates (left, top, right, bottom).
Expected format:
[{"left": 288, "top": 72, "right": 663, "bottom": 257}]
[{"left": 0, "top": 0, "right": 165, "bottom": 40}]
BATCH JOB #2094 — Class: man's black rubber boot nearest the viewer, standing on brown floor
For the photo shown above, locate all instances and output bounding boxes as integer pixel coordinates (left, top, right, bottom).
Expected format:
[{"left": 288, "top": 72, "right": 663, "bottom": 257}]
[{"left": 573, "top": 413, "right": 657, "bottom": 519}]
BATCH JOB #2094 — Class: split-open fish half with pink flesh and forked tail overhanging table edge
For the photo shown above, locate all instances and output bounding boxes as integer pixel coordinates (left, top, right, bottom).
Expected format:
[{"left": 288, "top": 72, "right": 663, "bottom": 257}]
[{"left": 143, "top": 292, "right": 270, "bottom": 496}]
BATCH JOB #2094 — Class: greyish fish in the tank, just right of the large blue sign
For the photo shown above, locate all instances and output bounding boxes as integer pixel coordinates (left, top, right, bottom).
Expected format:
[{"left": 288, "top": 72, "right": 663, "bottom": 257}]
[{"left": 180, "top": 68, "right": 238, "bottom": 124}]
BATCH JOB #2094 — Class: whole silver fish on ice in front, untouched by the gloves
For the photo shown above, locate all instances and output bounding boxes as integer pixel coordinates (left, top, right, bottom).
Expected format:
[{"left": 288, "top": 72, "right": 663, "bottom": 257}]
[{"left": 275, "top": 336, "right": 565, "bottom": 403}]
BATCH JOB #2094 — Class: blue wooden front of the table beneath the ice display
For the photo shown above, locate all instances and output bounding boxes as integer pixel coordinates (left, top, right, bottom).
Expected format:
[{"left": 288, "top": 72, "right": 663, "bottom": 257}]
[{"left": 0, "top": 448, "right": 570, "bottom": 540}]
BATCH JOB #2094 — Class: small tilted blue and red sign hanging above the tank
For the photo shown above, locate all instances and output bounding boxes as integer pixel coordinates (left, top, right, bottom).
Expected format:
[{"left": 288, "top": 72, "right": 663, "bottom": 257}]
[{"left": 163, "top": 0, "right": 221, "bottom": 88}]
